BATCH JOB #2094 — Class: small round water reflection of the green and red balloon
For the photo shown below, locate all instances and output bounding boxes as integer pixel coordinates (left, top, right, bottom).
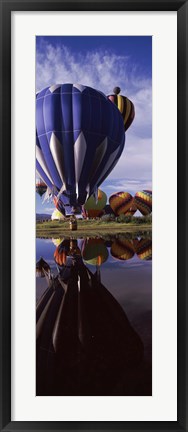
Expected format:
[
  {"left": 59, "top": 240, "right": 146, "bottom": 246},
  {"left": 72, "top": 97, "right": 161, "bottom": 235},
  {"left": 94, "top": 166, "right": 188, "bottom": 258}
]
[{"left": 82, "top": 238, "right": 108, "bottom": 266}]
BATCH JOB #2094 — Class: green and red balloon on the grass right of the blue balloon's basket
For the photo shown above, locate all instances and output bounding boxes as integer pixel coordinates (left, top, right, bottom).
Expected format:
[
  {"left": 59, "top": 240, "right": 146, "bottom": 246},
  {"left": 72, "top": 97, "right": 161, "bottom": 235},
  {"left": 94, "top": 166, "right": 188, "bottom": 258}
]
[{"left": 84, "top": 189, "right": 107, "bottom": 218}]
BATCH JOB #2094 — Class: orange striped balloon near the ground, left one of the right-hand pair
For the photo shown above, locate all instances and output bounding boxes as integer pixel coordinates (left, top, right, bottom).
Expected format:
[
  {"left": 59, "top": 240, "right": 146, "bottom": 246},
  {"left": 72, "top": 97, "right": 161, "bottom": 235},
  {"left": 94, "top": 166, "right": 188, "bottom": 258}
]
[{"left": 109, "top": 192, "right": 134, "bottom": 216}]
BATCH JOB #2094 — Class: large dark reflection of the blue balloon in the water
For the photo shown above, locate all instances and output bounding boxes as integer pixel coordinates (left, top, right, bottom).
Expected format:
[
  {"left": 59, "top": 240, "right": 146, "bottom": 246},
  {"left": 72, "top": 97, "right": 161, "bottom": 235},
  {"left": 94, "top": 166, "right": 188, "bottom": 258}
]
[{"left": 36, "top": 238, "right": 143, "bottom": 396}]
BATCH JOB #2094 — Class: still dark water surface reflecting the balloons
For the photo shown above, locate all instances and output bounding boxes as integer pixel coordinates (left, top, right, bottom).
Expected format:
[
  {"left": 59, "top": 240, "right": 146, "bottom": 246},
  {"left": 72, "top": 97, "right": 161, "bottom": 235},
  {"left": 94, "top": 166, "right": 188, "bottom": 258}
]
[{"left": 36, "top": 236, "right": 152, "bottom": 396}]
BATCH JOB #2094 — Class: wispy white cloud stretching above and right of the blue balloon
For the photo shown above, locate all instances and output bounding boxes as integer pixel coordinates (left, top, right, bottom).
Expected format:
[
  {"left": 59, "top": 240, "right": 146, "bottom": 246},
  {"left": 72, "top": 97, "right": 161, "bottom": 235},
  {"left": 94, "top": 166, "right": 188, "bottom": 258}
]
[{"left": 36, "top": 38, "right": 152, "bottom": 189}]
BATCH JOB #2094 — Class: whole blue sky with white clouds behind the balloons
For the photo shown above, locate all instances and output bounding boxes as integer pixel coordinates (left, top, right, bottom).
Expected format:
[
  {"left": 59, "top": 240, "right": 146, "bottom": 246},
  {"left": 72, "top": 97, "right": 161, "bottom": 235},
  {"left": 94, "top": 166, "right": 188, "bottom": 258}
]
[{"left": 36, "top": 36, "right": 152, "bottom": 213}]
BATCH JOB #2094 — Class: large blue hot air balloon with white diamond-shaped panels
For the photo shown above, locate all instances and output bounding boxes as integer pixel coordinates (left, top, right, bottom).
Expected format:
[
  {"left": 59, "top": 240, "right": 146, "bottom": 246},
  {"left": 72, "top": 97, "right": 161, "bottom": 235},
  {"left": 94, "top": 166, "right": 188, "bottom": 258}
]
[{"left": 36, "top": 84, "right": 125, "bottom": 211}]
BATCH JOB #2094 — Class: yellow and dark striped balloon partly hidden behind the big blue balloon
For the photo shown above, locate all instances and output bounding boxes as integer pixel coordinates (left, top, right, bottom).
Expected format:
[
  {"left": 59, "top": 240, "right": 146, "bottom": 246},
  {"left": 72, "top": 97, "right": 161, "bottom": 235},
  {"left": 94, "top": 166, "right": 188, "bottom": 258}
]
[{"left": 108, "top": 87, "right": 135, "bottom": 131}]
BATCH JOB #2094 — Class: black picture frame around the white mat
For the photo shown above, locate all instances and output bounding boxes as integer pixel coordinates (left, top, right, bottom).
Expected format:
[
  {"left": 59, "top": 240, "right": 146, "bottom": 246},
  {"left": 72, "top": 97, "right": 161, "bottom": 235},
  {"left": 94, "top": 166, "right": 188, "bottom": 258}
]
[{"left": 0, "top": 0, "right": 188, "bottom": 432}]
